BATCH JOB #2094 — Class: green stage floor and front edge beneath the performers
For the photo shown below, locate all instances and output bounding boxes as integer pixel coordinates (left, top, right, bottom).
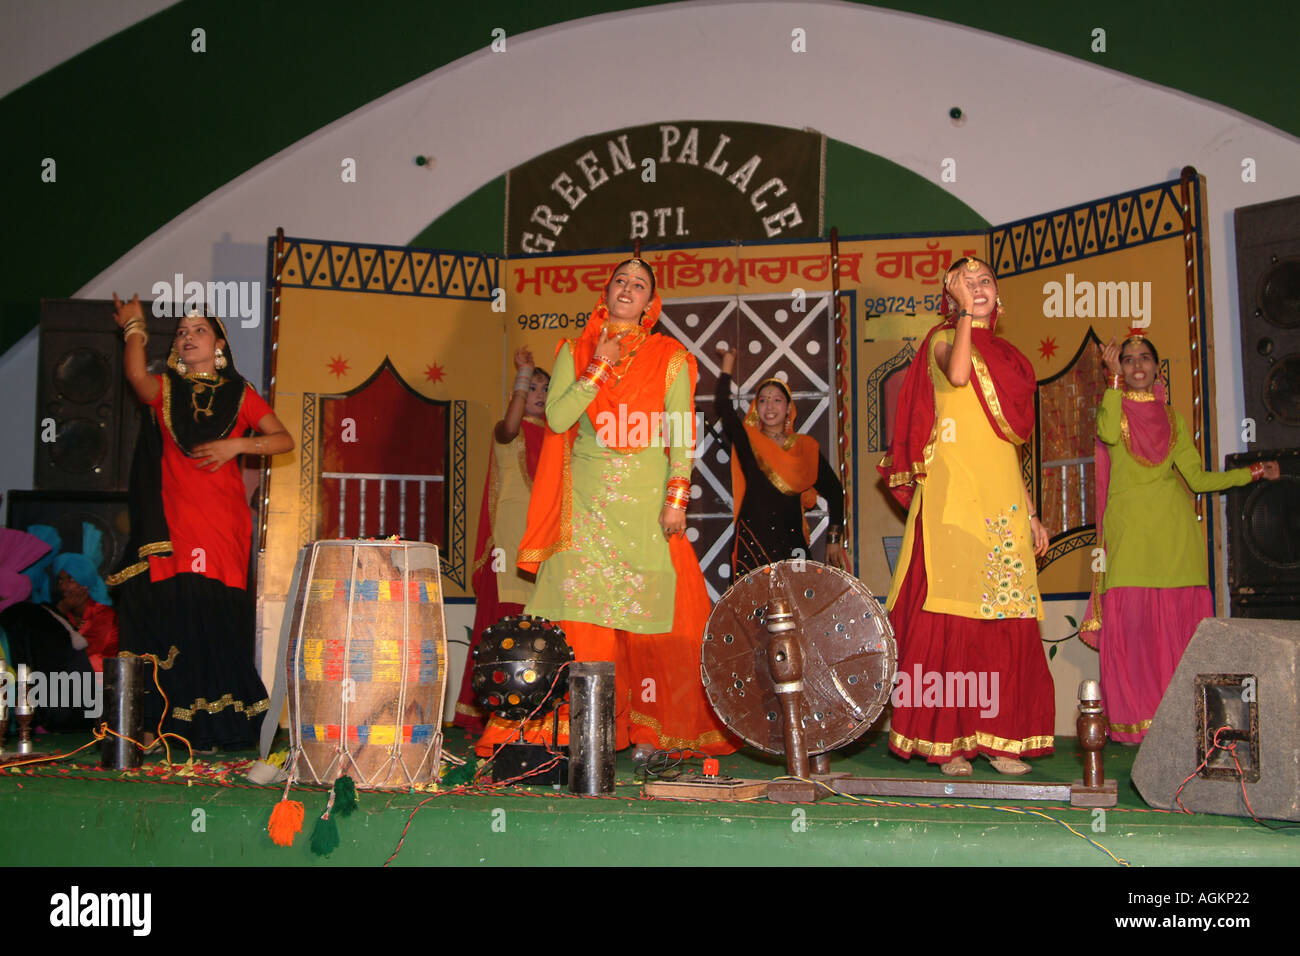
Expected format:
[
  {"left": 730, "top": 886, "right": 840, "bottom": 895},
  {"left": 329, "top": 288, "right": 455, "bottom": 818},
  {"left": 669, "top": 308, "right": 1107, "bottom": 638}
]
[{"left": 0, "top": 730, "right": 1300, "bottom": 868}]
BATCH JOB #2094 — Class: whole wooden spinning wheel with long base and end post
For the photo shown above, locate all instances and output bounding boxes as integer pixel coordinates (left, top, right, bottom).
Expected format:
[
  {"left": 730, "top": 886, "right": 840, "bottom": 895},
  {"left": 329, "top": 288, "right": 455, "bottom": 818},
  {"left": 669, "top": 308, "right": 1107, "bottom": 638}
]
[{"left": 702, "top": 561, "right": 1118, "bottom": 808}]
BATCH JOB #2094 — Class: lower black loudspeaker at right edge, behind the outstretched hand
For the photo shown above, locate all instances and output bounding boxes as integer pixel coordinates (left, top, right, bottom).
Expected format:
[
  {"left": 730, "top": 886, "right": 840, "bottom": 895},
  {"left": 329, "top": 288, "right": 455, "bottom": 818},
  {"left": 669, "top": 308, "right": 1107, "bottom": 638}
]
[{"left": 1225, "top": 449, "right": 1300, "bottom": 620}]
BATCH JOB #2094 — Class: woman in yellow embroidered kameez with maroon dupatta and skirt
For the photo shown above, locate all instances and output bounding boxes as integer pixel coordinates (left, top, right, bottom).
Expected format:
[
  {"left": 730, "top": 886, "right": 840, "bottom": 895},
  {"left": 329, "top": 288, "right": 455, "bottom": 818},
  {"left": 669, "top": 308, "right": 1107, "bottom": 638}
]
[{"left": 879, "top": 258, "right": 1056, "bottom": 775}]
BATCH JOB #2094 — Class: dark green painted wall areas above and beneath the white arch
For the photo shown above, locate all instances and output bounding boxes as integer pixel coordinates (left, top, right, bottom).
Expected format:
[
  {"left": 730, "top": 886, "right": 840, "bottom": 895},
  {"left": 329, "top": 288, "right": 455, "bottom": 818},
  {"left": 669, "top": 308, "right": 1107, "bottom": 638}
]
[{"left": 0, "top": 0, "right": 1300, "bottom": 351}]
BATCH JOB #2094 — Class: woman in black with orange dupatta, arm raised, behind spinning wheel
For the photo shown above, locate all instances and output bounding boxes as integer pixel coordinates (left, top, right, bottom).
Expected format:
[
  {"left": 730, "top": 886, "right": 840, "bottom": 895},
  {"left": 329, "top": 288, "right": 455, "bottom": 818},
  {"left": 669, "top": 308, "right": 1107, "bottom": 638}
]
[{"left": 714, "top": 350, "right": 848, "bottom": 579}]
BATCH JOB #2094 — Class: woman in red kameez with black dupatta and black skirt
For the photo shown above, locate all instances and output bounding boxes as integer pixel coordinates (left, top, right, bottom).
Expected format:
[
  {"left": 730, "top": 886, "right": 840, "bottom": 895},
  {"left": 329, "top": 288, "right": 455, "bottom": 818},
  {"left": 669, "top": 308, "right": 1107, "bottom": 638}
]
[{"left": 111, "top": 295, "right": 294, "bottom": 752}]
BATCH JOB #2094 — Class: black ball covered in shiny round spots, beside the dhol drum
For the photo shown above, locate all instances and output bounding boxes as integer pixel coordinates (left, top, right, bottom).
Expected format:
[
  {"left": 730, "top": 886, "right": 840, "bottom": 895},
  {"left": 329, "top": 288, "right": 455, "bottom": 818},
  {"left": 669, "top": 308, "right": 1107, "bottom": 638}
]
[{"left": 471, "top": 614, "right": 573, "bottom": 721}]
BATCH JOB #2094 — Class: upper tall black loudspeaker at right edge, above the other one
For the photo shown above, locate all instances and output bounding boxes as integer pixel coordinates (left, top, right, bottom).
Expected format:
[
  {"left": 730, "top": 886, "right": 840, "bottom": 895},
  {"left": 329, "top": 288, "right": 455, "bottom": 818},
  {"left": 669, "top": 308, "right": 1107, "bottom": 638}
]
[{"left": 1232, "top": 196, "right": 1300, "bottom": 447}]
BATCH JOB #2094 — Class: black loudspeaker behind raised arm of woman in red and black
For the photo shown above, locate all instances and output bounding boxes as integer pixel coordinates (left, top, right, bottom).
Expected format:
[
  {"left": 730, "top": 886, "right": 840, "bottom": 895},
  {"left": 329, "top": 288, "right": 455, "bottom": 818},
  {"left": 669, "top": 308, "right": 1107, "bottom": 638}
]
[{"left": 33, "top": 299, "right": 176, "bottom": 492}]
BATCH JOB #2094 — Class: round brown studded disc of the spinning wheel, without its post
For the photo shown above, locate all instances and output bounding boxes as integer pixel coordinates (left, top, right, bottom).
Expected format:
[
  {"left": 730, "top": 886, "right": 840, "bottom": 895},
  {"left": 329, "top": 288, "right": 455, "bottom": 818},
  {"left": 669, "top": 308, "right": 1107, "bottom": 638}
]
[{"left": 701, "top": 561, "right": 897, "bottom": 754}]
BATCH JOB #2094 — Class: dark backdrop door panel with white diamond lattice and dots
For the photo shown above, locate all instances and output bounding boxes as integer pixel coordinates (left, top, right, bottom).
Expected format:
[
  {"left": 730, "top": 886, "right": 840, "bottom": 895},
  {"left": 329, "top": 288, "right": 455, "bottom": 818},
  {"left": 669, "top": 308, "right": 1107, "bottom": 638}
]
[{"left": 659, "top": 293, "right": 839, "bottom": 601}]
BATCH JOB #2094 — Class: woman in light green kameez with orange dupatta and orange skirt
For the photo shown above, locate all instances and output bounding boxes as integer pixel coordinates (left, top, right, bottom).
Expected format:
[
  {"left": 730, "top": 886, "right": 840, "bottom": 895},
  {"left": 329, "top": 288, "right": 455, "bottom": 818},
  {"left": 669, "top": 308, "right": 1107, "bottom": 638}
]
[{"left": 476, "top": 259, "right": 738, "bottom": 757}]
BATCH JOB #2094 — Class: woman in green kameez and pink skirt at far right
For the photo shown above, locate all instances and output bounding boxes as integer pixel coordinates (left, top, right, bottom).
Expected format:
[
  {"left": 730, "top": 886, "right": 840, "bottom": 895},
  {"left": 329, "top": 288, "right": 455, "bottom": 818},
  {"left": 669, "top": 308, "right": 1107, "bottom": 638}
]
[{"left": 1082, "top": 334, "right": 1278, "bottom": 744}]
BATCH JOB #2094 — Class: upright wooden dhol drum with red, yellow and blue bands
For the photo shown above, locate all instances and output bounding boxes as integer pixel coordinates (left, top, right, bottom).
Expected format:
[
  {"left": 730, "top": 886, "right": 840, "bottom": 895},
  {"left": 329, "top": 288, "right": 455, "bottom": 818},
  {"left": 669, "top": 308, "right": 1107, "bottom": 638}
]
[{"left": 286, "top": 540, "right": 447, "bottom": 788}]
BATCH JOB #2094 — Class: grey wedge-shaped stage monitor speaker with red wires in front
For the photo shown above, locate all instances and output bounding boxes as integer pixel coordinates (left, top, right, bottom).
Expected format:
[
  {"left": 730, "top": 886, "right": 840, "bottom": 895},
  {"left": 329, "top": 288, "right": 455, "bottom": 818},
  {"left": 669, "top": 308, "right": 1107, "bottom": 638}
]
[{"left": 1134, "top": 618, "right": 1300, "bottom": 821}]
